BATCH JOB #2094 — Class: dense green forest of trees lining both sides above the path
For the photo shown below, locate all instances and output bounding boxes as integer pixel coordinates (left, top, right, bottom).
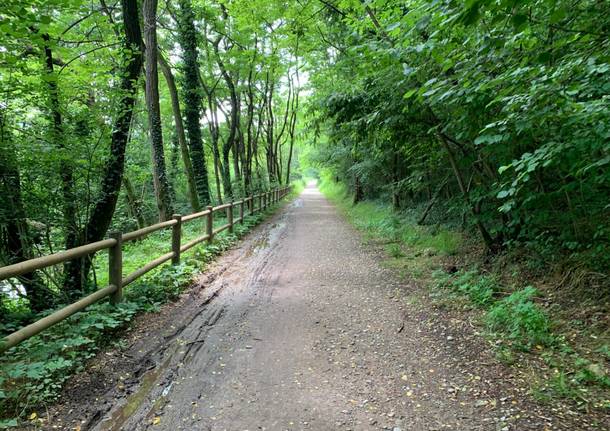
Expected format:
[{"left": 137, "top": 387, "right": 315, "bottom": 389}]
[{"left": 0, "top": 0, "right": 610, "bottom": 426}]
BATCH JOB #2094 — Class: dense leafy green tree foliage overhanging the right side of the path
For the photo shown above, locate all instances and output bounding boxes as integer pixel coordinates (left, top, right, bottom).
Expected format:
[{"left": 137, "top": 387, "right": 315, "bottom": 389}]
[{"left": 309, "top": 0, "right": 610, "bottom": 272}]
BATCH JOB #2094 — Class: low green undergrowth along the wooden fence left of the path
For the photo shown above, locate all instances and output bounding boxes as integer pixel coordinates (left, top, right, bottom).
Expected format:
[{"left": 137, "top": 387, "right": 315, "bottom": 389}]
[{"left": 0, "top": 195, "right": 298, "bottom": 429}]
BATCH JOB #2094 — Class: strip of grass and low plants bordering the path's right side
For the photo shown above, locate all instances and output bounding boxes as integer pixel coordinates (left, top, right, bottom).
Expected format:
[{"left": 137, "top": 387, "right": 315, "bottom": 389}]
[{"left": 321, "top": 180, "right": 610, "bottom": 411}]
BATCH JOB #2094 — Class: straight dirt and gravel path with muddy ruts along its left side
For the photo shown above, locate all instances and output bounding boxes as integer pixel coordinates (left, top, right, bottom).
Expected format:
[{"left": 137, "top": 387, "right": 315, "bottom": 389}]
[{"left": 52, "top": 188, "right": 604, "bottom": 431}]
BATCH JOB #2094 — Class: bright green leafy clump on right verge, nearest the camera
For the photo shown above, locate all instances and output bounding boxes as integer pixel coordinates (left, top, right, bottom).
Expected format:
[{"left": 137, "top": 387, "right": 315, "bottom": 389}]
[{"left": 486, "top": 286, "right": 555, "bottom": 349}]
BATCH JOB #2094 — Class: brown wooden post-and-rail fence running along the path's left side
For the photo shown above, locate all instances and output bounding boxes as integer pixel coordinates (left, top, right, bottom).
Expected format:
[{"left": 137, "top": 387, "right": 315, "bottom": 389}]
[{"left": 0, "top": 186, "right": 290, "bottom": 353}]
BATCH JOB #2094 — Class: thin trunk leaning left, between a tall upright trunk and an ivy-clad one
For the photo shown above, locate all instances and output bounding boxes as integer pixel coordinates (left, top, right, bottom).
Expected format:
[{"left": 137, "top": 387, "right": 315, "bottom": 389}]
[{"left": 159, "top": 53, "right": 200, "bottom": 212}]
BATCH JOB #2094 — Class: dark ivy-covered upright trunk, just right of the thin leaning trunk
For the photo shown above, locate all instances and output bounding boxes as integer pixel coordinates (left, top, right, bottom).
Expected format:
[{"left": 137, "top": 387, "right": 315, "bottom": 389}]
[{"left": 178, "top": 0, "right": 210, "bottom": 205}]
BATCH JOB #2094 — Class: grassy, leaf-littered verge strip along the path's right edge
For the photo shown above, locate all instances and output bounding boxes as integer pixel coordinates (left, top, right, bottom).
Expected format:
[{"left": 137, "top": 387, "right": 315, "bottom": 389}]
[{"left": 320, "top": 179, "right": 610, "bottom": 409}]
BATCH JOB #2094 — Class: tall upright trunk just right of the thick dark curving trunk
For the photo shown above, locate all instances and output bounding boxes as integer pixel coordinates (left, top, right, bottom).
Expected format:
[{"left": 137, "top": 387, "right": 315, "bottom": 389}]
[{"left": 142, "top": 0, "right": 173, "bottom": 221}]
